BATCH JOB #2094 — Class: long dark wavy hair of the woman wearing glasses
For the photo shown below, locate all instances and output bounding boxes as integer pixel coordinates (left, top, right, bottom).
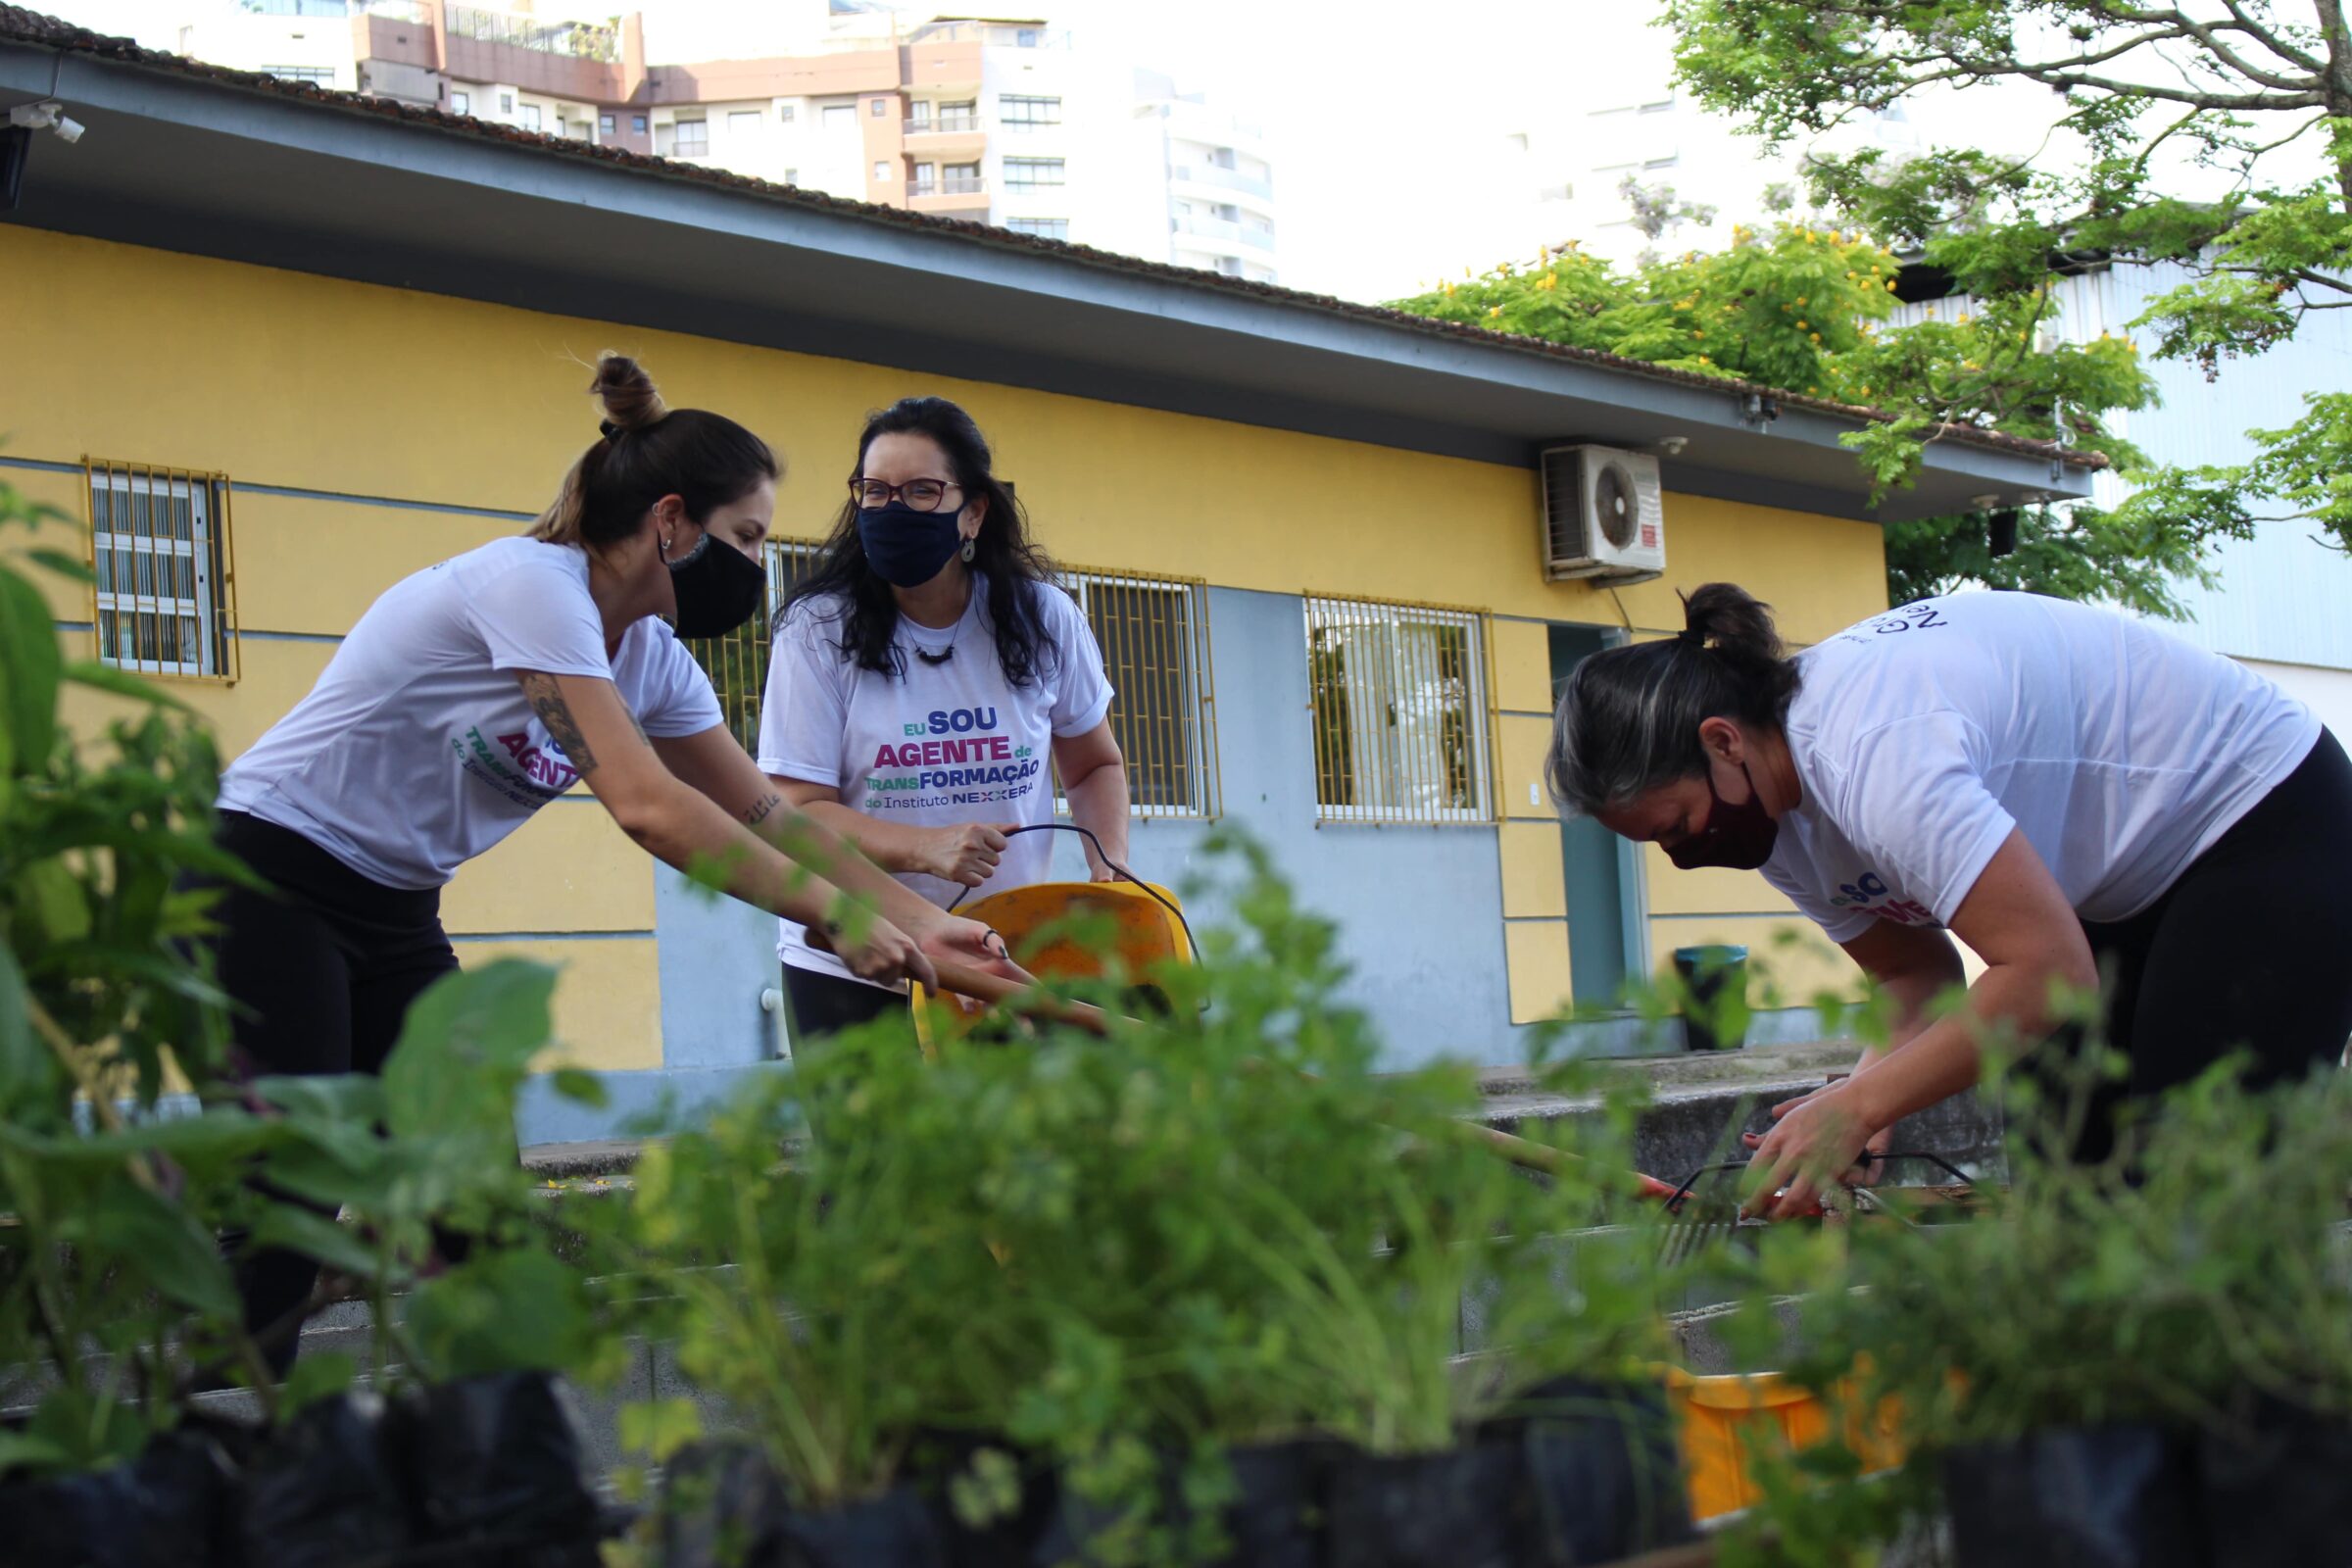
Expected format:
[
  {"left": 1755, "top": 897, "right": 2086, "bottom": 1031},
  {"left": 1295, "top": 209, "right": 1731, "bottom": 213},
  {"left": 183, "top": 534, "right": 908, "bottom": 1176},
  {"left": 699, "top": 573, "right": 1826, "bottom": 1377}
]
[{"left": 776, "top": 397, "right": 1054, "bottom": 686}]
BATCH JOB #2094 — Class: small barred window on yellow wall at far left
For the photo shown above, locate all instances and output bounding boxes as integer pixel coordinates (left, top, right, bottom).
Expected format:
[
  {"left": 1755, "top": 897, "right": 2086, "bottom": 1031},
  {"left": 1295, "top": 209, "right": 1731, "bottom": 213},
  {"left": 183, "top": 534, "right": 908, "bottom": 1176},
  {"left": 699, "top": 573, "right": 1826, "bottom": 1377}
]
[{"left": 82, "top": 459, "right": 237, "bottom": 682}]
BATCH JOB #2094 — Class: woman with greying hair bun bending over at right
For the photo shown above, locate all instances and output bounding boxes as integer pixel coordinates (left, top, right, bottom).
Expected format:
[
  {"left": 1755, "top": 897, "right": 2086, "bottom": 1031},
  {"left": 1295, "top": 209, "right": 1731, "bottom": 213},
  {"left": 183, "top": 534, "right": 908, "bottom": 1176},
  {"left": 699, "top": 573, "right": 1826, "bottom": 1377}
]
[{"left": 1547, "top": 583, "right": 2352, "bottom": 1215}]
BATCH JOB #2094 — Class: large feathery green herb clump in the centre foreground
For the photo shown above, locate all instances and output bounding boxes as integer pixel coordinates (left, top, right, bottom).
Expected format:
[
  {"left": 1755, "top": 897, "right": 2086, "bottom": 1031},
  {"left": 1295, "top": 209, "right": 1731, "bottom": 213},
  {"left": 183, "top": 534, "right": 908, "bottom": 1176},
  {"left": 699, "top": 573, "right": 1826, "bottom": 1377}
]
[{"left": 597, "top": 847, "right": 1684, "bottom": 1563}]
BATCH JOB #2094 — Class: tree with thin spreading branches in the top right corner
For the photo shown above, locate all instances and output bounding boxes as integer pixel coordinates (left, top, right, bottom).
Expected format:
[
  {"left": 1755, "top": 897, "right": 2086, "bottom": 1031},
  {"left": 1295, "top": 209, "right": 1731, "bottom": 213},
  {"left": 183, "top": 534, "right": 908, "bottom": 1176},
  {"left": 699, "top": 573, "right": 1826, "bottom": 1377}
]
[{"left": 1660, "top": 0, "right": 2352, "bottom": 562}]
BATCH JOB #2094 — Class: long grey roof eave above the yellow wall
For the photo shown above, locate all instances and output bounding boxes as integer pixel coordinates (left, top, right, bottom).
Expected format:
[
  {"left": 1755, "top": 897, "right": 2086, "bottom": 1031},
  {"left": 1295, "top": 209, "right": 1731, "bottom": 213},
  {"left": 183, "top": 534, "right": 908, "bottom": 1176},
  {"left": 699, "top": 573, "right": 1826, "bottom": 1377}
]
[{"left": 0, "top": 25, "right": 2088, "bottom": 519}]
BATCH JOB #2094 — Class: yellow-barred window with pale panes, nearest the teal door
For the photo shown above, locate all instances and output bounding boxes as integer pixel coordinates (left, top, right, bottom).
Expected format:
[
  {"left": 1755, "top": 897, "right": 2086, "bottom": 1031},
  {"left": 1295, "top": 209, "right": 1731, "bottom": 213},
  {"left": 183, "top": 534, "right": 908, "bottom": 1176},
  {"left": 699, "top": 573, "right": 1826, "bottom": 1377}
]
[{"left": 1303, "top": 595, "right": 1494, "bottom": 823}]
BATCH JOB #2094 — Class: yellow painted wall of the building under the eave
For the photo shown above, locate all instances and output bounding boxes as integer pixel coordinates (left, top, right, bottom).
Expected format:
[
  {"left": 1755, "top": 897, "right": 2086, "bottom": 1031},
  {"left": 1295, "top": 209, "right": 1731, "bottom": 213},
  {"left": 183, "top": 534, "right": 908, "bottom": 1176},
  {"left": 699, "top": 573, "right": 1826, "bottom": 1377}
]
[{"left": 0, "top": 228, "right": 1886, "bottom": 1065}]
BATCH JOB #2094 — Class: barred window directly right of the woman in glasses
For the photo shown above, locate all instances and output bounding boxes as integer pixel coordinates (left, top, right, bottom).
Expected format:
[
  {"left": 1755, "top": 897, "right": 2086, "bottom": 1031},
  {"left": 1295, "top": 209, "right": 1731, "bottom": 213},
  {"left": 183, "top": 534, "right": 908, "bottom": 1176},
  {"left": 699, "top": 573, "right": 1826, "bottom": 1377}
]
[{"left": 1060, "top": 566, "right": 1223, "bottom": 818}]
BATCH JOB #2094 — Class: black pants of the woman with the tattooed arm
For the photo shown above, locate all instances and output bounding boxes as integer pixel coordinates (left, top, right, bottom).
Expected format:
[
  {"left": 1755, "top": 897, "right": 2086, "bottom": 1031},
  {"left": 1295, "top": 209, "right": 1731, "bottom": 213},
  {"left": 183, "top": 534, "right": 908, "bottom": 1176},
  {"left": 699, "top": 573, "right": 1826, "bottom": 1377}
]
[{"left": 214, "top": 811, "right": 459, "bottom": 1373}]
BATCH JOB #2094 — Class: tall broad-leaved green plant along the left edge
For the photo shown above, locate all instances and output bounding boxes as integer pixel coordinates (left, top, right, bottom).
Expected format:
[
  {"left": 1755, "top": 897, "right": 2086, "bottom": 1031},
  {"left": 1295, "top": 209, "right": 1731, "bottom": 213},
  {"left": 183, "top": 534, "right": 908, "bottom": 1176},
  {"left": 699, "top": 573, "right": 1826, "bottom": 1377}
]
[{"left": 0, "top": 482, "right": 289, "bottom": 1469}]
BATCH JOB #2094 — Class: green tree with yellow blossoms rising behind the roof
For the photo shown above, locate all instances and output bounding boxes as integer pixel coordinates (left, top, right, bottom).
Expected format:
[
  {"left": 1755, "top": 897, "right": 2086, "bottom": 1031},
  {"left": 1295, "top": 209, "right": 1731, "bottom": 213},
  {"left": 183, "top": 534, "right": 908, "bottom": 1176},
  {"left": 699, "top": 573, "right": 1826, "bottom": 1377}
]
[{"left": 1397, "top": 226, "right": 2206, "bottom": 613}]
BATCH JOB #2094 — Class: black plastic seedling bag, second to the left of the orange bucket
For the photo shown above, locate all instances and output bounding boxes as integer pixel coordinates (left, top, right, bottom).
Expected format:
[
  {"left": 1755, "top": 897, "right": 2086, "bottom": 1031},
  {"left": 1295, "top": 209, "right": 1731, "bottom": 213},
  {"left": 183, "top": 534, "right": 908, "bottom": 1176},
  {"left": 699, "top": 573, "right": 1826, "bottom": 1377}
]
[{"left": 1329, "top": 1441, "right": 1539, "bottom": 1568}]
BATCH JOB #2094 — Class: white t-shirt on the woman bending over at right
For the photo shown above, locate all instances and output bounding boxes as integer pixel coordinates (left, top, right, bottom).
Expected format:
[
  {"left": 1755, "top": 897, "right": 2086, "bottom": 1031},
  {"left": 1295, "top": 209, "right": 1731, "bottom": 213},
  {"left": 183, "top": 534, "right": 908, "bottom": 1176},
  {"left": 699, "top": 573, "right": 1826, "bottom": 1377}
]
[{"left": 1764, "top": 592, "right": 2319, "bottom": 943}]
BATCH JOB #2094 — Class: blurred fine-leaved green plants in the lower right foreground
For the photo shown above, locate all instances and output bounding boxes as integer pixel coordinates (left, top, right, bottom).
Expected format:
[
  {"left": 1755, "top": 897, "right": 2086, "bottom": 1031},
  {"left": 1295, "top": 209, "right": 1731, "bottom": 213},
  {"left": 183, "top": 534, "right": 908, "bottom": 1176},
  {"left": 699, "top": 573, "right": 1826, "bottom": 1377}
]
[{"left": 1809, "top": 1065, "right": 2352, "bottom": 1444}]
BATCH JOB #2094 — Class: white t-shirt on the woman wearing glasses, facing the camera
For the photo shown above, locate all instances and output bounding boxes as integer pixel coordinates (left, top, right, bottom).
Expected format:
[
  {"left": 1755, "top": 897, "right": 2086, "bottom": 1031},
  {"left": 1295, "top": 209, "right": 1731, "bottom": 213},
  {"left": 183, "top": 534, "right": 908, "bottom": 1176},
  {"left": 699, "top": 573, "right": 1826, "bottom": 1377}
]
[{"left": 760, "top": 578, "right": 1110, "bottom": 978}]
